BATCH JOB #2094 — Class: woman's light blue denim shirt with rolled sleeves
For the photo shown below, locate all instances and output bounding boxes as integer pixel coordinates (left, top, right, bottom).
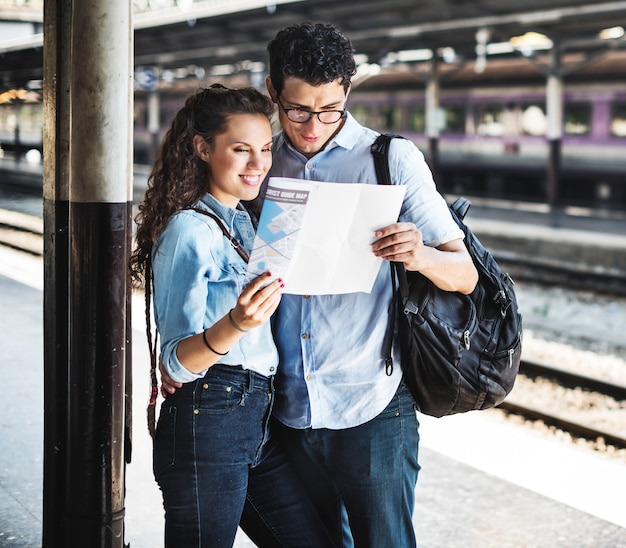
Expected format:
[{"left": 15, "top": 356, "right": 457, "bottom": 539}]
[{"left": 152, "top": 194, "right": 278, "bottom": 382}]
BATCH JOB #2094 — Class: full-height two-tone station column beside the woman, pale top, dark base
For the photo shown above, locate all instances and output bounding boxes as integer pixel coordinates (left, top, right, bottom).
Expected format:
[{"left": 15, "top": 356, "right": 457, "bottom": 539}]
[{"left": 44, "top": 0, "right": 132, "bottom": 548}]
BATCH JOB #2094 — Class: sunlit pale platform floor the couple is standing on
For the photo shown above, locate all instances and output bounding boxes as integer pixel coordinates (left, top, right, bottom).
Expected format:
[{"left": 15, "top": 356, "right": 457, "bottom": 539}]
[{"left": 0, "top": 247, "right": 626, "bottom": 548}]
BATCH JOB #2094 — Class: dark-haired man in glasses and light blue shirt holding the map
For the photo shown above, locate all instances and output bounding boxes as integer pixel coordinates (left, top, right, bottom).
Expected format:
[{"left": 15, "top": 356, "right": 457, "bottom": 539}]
[{"left": 163, "top": 23, "right": 478, "bottom": 548}]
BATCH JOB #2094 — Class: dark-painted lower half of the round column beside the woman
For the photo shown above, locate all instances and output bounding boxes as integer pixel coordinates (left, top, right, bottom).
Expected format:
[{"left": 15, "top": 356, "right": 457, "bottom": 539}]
[{"left": 65, "top": 201, "right": 131, "bottom": 548}]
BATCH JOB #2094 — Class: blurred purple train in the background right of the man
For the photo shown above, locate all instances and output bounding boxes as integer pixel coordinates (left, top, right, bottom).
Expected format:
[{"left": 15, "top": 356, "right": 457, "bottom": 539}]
[{"left": 349, "top": 82, "right": 626, "bottom": 209}]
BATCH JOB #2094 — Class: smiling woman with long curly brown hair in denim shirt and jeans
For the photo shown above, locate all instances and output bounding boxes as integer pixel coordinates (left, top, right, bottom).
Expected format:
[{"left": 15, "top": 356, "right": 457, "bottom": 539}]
[{"left": 130, "top": 85, "right": 331, "bottom": 548}]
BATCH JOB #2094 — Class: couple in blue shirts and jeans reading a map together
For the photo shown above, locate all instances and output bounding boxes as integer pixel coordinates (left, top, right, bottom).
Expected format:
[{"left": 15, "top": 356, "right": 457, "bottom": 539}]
[{"left": 131, "top": 23, "right": 477, "bottom": 548}]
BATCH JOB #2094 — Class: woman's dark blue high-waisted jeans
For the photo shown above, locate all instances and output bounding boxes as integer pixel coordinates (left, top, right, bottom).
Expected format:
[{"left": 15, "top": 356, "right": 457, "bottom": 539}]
[{"left": 153, "top": 365, "right": 332, "bottom": 548}]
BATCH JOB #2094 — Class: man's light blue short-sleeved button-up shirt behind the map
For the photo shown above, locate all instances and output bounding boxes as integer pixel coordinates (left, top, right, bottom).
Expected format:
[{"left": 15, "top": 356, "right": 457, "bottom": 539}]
[{"left": 268, "top": 114, "right": 463, "bottom": 429}]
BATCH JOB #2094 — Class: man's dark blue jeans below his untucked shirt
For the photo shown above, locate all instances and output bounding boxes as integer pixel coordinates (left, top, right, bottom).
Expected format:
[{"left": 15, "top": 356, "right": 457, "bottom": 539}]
[{"left": 275, "top": 383, "right": 420, "bottom": 548}]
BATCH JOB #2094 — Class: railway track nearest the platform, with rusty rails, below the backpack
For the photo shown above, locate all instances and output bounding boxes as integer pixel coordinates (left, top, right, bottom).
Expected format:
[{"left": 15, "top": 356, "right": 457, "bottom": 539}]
[{"left": 498, "top": 360, "right": 626, "bottom": 449}]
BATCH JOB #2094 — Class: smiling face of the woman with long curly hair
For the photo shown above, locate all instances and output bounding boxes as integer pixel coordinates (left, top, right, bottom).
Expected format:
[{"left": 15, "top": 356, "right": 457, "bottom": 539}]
[{"left": 201, "top": 114, "right": 272, "bottom": 207}]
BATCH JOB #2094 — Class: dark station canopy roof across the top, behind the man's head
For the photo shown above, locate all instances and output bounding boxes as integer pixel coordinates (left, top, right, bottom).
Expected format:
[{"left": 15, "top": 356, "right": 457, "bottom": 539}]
[{"left": 0, "top": 0, "right": 626, "bottom": 89}]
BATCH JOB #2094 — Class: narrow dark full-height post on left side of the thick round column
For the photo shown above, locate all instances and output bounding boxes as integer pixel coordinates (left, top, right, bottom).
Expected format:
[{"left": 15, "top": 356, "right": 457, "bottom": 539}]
[{"left": 42, "top": 0, "right": 72, "bottom": 548}]
